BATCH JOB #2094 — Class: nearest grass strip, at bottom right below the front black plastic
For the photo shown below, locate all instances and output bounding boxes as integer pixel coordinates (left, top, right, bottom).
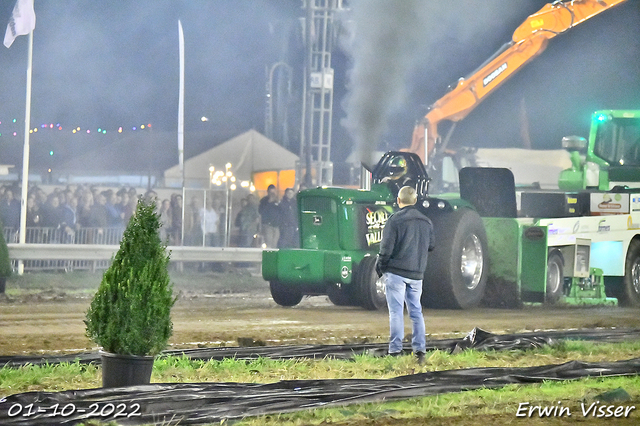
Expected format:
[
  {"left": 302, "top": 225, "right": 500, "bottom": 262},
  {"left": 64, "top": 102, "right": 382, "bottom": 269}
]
[{"left": 234, "top": 376, "right": 640, "bottom": 426}]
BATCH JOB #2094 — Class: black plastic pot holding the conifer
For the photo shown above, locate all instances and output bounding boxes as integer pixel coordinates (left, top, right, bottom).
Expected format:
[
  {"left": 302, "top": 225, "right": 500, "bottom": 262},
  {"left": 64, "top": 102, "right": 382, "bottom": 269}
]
[{"left": 100, "top": 351, "right": 154, "bottom": 388}]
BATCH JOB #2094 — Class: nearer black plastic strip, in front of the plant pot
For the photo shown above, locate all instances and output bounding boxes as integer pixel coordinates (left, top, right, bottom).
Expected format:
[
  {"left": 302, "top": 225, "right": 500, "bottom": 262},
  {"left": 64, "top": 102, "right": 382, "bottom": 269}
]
[{"left": 0, "top": 358, "right": 640, "bottom": 425}]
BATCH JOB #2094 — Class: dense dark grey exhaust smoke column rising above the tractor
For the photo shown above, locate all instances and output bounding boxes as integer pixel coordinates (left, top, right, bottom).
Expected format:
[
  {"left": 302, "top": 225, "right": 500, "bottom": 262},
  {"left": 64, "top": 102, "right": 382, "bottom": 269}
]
[{"left": 342, "top": 0, "right": 427, "bottom": 165}]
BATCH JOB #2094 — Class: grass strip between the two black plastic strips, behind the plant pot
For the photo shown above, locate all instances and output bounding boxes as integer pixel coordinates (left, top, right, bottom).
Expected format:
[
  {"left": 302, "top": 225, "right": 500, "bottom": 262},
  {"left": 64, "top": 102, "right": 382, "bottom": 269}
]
[{"left": 5, "top": 341, "right": 640, "bottom": 396}]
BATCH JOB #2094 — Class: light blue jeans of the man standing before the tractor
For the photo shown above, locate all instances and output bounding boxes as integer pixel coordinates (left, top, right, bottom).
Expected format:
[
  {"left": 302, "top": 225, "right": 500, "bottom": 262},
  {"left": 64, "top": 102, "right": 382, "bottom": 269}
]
[{"left": 382, "top": 272, "right": 426, "bottom": 354}]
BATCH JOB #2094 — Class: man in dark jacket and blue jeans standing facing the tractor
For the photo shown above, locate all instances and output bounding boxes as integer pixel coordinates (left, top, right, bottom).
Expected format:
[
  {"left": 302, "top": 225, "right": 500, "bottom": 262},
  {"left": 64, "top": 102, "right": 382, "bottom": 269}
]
[{"left": 376, "top": 186, "right": 434, "bottom": 364}]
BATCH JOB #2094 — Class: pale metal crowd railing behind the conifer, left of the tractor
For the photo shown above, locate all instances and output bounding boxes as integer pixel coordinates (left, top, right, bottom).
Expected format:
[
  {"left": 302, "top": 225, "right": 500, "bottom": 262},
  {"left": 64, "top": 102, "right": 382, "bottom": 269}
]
[{"left": 4, "top": 228, "right": 262, "bottom": 272}]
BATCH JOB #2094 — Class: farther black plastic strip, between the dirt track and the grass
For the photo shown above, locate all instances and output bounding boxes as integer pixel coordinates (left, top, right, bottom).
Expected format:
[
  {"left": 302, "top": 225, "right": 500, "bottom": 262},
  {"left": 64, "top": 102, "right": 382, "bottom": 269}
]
[{"left": 0, "top": 328, "right": 640, "bottom": 368}]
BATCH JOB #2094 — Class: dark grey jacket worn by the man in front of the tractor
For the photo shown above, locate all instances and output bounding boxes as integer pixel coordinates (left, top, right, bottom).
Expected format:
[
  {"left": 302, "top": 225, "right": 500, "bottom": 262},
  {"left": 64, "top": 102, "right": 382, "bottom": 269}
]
[{"left": 376, "top": 206, "right": 434, "bottom": 280}]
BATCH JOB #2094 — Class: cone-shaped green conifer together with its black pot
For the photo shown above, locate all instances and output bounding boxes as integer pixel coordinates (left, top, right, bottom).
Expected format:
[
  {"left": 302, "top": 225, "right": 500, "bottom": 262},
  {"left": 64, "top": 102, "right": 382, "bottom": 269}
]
[{"left": 85, "top": 200, "right": 176, "bottom": 388}]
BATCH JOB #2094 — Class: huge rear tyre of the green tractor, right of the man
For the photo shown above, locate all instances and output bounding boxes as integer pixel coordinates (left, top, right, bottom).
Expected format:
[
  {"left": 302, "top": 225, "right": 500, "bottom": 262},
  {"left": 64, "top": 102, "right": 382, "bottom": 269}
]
[{"left": 422, "top": 208, "right": 489, "bottom": 309}]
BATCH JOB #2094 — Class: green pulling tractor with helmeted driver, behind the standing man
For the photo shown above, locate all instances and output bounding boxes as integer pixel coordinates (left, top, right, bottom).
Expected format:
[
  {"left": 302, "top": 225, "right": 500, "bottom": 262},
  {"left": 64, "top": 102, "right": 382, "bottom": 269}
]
[{"left": 262, "top": 152, "right": 487, "bottom": 310}]
